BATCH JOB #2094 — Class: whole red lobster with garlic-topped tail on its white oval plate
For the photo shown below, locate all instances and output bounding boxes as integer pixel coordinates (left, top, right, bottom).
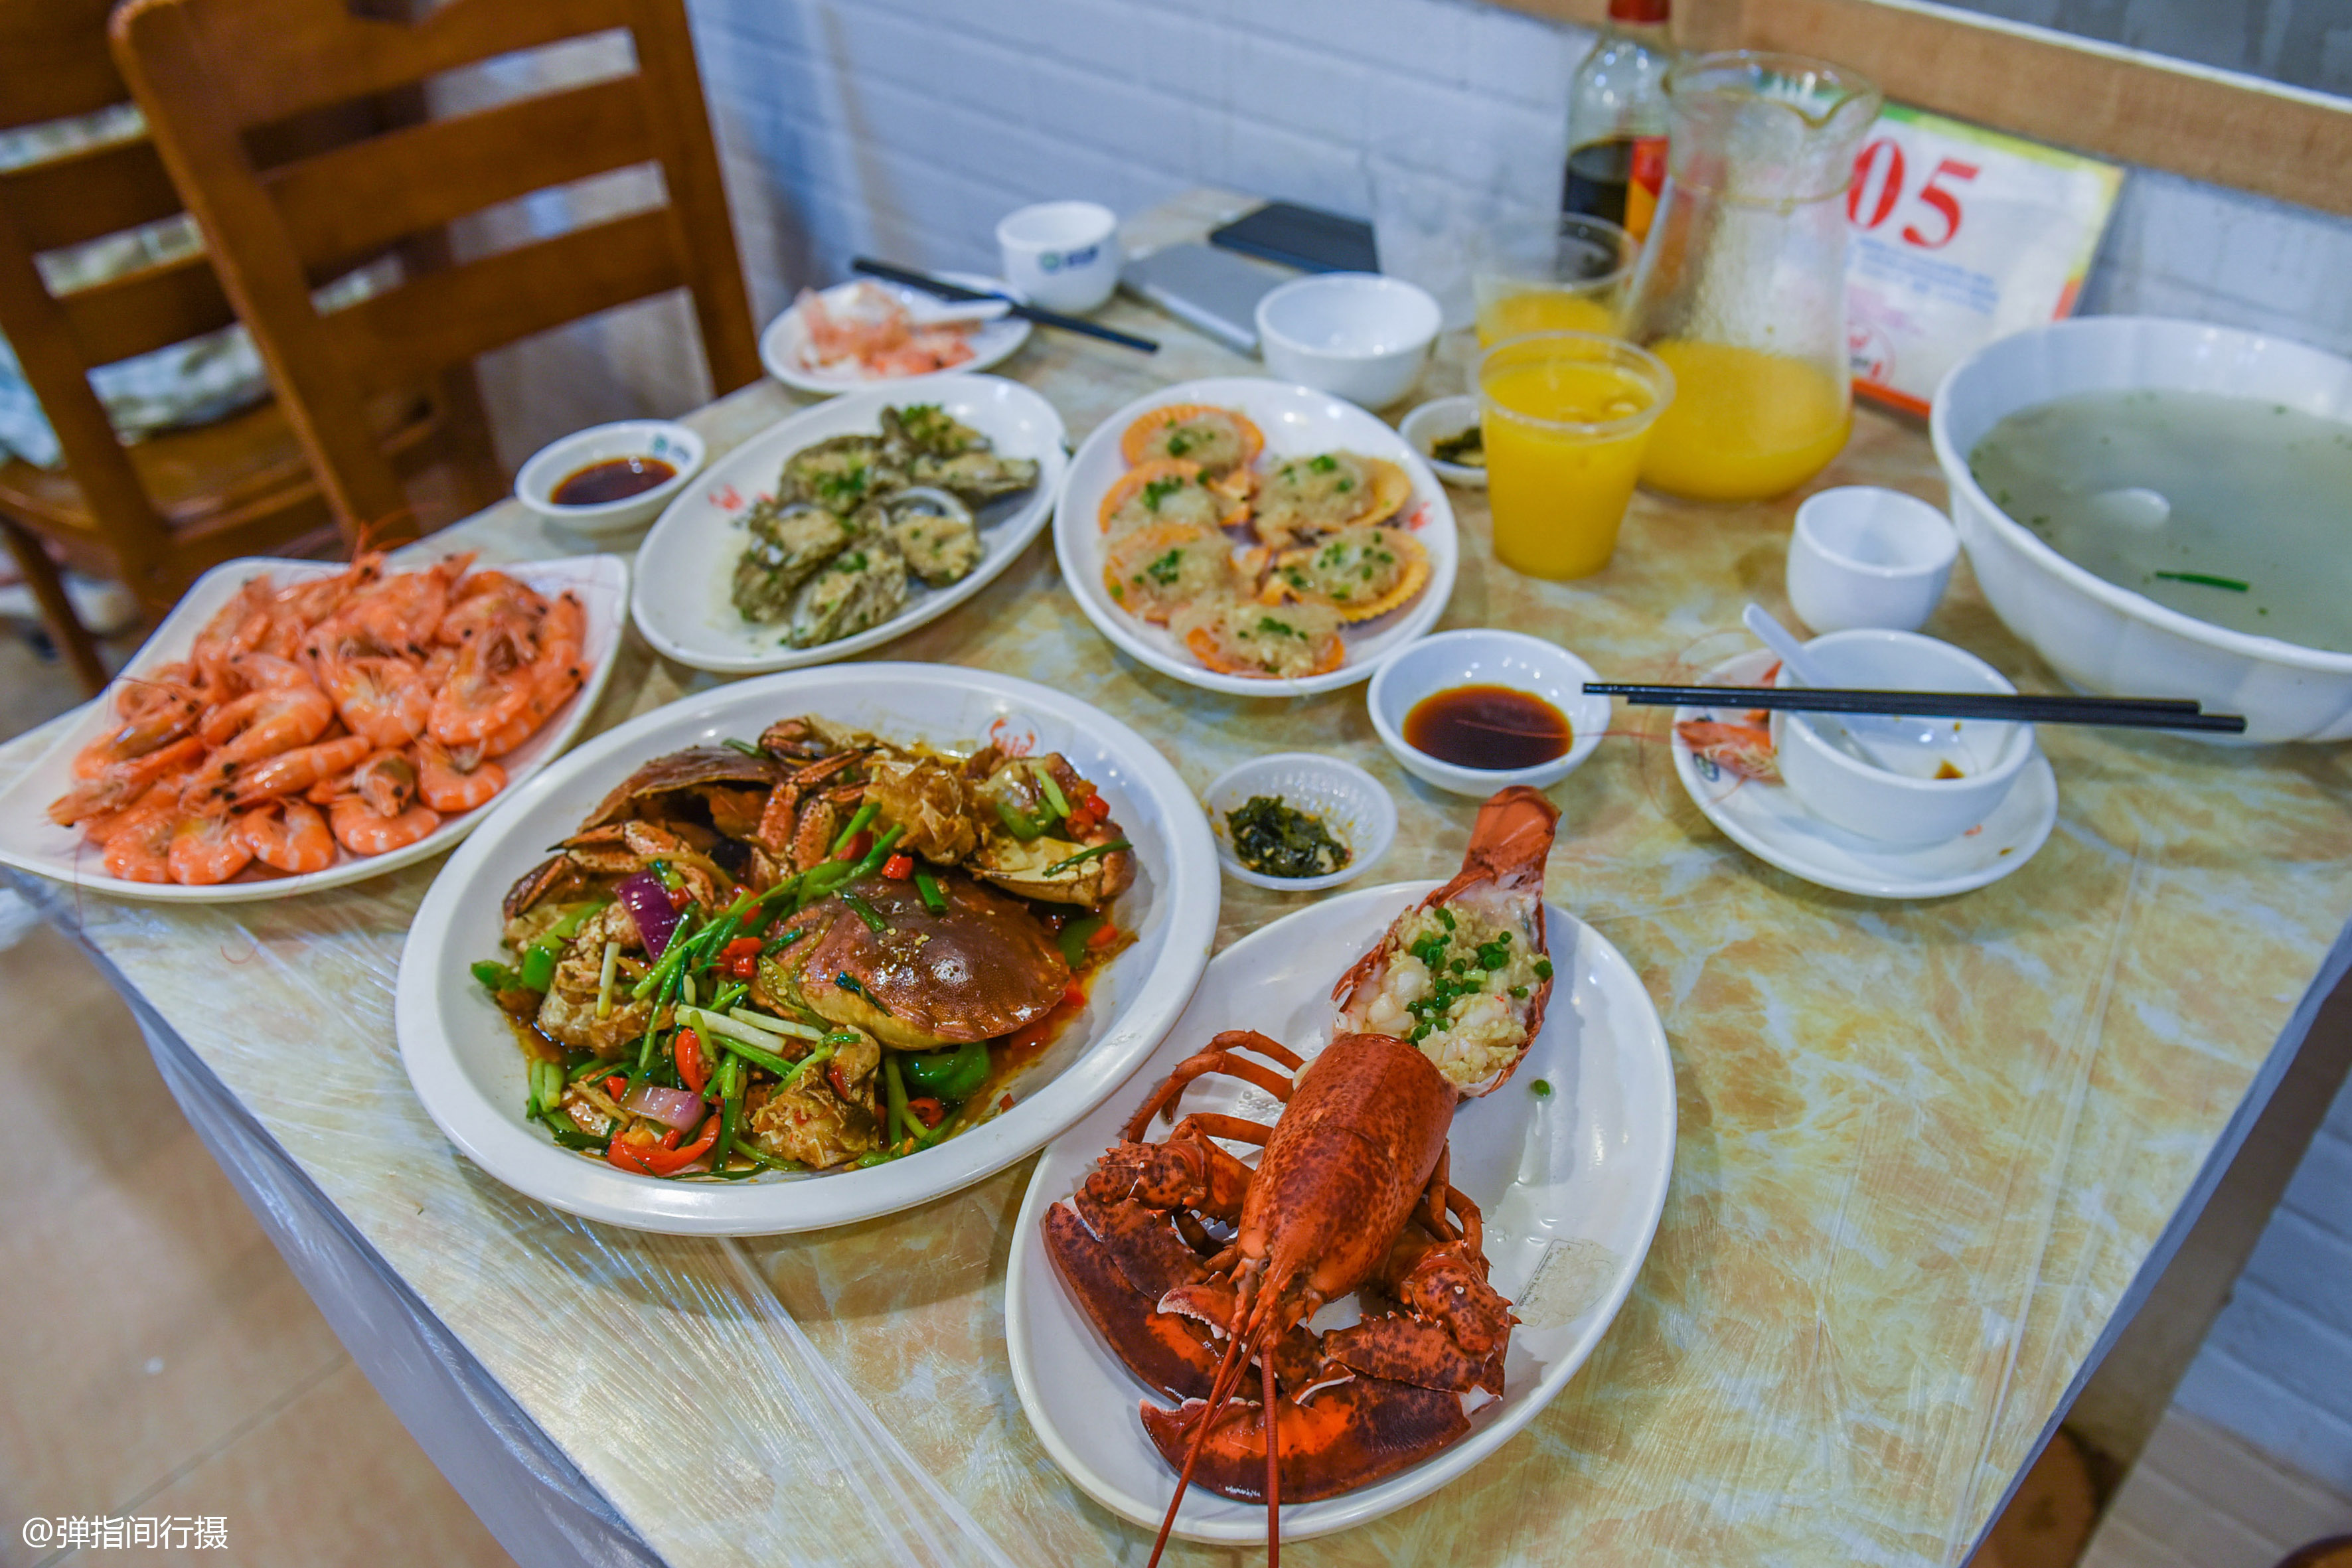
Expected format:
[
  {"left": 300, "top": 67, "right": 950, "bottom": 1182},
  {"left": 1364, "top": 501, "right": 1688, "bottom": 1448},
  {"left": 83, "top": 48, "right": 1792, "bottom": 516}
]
[{"left": 1004, "top": 787, "right": 1675, "bottom": 1545}]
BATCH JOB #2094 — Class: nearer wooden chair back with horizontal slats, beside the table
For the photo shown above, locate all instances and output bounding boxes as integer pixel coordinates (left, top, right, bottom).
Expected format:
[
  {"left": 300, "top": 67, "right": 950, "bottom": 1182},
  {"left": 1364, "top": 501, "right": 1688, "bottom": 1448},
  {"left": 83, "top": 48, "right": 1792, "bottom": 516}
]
[{"left": 113, "top": 0, "right": 759, "bottom": 526}]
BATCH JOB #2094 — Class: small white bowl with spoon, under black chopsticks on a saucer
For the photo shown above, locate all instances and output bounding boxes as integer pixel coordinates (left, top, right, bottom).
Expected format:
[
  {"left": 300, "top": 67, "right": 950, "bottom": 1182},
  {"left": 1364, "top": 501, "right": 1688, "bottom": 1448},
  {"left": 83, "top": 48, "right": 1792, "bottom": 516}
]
[{"left": 1771, "top": 630, "right": 2037, "bottom": 846}]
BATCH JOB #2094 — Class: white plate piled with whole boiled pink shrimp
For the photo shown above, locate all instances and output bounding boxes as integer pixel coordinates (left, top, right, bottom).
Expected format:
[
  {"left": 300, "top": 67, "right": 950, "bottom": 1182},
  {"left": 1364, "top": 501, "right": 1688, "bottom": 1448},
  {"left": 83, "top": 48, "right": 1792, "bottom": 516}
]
[{"left": 0, "top": 552, "right": 628, "bottom": 903}]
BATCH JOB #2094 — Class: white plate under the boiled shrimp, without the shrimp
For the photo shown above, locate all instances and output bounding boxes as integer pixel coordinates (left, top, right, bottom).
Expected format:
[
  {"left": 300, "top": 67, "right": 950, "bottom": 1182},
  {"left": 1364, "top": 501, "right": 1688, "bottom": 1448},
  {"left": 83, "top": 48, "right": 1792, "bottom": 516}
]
[{"left": 0, "top": 555, "right": 628, "bottom": 903}]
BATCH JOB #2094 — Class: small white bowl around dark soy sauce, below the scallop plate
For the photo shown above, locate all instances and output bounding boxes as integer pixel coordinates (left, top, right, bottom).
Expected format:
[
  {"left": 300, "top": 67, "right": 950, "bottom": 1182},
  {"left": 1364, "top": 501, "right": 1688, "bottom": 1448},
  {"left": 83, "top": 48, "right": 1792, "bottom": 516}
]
[{"left": 1364, "top": 628, "right": 1608, "bottom": 799}]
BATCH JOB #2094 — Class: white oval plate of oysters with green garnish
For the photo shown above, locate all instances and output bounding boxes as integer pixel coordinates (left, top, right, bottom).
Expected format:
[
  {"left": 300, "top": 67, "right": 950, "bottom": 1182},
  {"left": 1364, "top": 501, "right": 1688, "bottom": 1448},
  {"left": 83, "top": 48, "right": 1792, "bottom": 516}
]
[{"left": 631, "top": 374, "right": 1068, "bottom": 674}]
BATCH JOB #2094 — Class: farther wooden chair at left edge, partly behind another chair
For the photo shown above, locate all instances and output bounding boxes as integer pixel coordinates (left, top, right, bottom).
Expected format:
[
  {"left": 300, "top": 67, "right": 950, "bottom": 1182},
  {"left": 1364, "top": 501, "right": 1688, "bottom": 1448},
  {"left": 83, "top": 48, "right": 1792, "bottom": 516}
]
[{"left": 0, "top": 0, "right": 506, "bottom": 691}]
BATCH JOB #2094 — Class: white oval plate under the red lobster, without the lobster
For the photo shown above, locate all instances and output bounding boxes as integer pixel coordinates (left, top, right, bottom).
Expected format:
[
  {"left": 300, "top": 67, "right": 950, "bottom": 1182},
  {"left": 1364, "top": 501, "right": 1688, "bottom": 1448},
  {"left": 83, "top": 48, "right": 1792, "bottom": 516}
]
[{"left": 1004, "top": 882, "right": 1675, "bottom": 1545}]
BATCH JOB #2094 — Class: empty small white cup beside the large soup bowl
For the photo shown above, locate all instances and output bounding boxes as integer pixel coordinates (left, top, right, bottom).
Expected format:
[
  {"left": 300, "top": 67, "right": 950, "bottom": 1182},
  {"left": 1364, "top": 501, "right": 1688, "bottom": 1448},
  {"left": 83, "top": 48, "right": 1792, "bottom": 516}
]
[{"left": 1788, "top": 484, "right": 1959, "bottom": 633}]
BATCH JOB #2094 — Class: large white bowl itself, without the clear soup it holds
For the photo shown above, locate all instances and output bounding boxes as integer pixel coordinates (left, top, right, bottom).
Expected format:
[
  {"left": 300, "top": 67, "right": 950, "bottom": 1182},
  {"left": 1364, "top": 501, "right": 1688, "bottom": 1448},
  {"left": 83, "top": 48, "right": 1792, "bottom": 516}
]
[{"left": 1928, "top": 315, "right": 2352, "bottom": 740}]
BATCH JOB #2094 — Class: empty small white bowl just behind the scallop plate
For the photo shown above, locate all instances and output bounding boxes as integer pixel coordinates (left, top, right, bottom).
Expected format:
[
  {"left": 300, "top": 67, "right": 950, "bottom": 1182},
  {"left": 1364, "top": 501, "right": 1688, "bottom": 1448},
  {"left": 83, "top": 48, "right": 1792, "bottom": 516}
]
[{"left": 1259, "top": 273, "right": 1439, "bottom": 409}]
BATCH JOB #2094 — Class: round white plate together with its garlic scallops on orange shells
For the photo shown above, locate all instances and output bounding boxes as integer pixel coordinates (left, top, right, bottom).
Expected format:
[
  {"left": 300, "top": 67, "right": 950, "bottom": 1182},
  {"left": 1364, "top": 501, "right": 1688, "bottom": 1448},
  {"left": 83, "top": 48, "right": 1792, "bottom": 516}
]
[{"left": 1054, "top": 376, "right": 1458, "bottom": 696}]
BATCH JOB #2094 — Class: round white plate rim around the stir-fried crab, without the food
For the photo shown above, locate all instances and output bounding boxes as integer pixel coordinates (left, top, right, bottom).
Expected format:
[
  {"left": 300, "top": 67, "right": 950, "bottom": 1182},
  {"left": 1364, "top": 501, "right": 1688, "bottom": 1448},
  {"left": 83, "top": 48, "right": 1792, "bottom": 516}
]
[{"left": 393, "top": 663, "right": 1218, "bottom": 1237}]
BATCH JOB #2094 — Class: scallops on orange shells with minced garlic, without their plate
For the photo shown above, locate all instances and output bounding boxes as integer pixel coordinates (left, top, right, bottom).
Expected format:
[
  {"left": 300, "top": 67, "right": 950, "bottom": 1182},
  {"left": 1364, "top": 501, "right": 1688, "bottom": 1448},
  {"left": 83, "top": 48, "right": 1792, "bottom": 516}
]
[{"left": 1096, "top": 404, "right": 1430, "bottom": 679}]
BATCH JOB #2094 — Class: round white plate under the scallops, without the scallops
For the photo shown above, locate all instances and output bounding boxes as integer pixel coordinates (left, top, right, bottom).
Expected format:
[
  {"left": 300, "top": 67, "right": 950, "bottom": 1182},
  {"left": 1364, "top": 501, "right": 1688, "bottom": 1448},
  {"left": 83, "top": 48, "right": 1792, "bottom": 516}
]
[{"left": 1054, "top": 376, "right": 1460, "bottom": 696}]
